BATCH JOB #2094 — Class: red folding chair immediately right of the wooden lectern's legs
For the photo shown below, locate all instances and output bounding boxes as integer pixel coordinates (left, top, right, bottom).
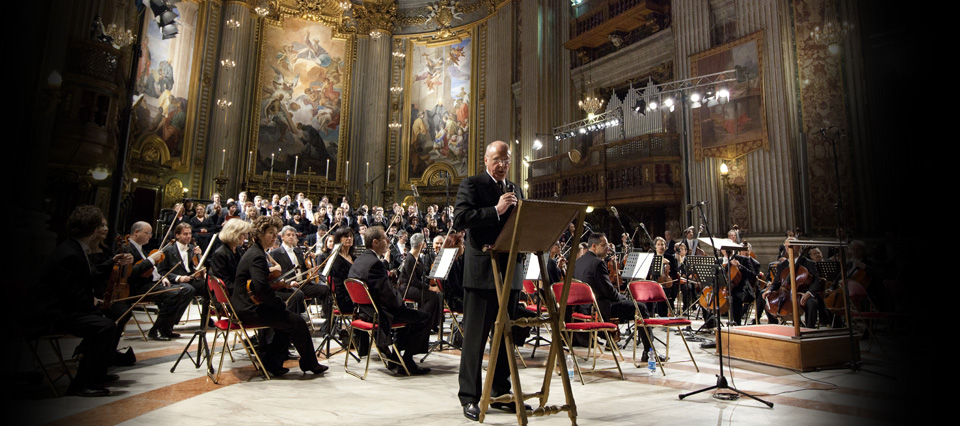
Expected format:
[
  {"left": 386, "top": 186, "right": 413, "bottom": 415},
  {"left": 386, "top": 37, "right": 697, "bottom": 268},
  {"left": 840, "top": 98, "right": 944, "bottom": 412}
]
[{"left": 551, "top": 281, "right": 624, "bottom": 384}]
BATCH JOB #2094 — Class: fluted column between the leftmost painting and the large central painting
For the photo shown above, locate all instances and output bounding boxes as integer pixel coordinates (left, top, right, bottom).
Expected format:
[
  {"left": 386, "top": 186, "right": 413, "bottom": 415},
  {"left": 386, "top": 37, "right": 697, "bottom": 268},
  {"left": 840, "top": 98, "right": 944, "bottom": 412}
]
[{"left": 199, "top": 2, "right": 258, "bottom": 199}]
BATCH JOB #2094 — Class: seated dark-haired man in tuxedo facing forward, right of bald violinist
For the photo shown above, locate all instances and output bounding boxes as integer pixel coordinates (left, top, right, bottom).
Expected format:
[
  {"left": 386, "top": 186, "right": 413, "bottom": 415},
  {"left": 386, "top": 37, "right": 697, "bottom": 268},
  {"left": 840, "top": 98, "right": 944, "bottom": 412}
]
[{"left": 156, "top": 223, "right": 208, "bottom": 340}]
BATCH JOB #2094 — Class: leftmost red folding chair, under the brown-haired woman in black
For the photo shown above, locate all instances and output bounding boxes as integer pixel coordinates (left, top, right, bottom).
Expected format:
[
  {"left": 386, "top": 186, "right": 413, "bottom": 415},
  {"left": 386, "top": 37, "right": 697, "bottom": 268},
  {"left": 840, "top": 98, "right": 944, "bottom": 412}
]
[{"left": 207, "top": 274, "right": 270, "bottom": 383}]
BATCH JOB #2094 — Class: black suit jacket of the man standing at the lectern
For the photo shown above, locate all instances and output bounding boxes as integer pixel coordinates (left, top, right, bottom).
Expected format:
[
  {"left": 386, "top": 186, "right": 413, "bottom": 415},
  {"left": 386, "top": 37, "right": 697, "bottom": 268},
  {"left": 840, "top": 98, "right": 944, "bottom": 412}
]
[{"left": 453, "top": 171, "right": 523, "bottom": 290}]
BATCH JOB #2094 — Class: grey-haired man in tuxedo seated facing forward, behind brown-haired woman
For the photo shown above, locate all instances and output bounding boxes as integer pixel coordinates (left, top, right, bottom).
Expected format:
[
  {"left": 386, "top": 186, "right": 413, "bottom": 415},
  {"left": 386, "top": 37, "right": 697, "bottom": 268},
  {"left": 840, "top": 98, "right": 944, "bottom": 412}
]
[{"left": 270, "top": 225, "right": 333, "bottom": 334}]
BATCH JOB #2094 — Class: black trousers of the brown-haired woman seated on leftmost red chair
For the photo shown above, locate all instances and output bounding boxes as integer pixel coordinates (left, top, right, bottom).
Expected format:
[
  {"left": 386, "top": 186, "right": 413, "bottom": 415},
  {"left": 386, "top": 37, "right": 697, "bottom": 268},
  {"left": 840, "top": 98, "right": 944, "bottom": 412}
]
[{"left": 237, "top": 303, "right": 319, "bottom": 371}]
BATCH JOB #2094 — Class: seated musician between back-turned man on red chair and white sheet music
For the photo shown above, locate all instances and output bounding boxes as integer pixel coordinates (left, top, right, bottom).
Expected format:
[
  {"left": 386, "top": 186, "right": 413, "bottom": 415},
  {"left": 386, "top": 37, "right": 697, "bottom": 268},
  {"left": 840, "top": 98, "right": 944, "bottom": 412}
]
[{"left": 399, "top": 234, "right": 443, "bottom": 329}]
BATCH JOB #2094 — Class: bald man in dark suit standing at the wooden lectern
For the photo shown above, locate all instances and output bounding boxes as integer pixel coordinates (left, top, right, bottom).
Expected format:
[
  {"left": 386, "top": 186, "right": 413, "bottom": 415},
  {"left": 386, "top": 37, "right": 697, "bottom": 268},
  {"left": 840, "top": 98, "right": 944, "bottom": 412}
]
[{"left": 453, "top": 141, "right": 523, "bottom": 421}]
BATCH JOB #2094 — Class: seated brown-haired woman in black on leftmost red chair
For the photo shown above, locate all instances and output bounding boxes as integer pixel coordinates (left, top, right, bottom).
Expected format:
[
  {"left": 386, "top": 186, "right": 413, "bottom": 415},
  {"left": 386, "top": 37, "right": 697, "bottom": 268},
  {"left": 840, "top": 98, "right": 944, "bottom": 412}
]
[{"left": 230, "top": 216, "right": 328, "bottom": 376}]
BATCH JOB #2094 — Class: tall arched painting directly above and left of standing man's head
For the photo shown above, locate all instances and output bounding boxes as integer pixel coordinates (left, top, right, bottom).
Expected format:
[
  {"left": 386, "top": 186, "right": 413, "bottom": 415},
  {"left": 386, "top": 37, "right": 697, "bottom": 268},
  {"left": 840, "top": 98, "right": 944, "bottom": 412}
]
[{"left": 401, "top": 33, "right": 475, "bottom": 184}]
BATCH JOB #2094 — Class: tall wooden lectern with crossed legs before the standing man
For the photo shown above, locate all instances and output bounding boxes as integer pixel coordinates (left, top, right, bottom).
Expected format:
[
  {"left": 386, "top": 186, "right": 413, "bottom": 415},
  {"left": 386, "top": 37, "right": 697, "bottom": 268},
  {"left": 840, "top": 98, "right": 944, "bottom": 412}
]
[{"left": 479, "top": 200, "right": 586, "bottom": 425}]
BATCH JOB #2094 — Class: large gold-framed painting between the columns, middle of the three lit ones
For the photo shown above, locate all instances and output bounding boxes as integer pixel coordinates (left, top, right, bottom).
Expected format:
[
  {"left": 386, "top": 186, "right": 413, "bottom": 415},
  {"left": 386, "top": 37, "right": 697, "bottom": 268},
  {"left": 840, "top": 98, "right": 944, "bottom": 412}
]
[{"left": 251, "top": 17, "right": 350, "bottom": 181}]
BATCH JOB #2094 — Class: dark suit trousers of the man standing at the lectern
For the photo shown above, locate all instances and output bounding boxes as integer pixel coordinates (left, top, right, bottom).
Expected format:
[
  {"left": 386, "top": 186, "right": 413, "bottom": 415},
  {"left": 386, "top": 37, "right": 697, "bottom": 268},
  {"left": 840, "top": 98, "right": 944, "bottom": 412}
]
[{"left": 458, "top": 288, "right": 520, "bottom": 405}]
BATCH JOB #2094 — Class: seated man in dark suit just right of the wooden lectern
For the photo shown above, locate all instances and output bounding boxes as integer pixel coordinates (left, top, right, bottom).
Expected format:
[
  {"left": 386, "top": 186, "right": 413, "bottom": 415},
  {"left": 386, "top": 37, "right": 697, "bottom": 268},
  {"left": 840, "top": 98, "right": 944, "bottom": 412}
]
[{"left": 573, "top": 232, "right": 650, "bottom": 362}]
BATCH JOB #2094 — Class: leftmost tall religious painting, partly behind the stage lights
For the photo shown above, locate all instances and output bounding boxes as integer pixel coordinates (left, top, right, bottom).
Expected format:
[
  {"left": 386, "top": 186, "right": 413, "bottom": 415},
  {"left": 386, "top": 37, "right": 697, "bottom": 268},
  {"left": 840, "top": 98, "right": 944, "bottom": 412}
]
[{"left": 131, "top": 1, "right": 201, "bottom": 170}]
